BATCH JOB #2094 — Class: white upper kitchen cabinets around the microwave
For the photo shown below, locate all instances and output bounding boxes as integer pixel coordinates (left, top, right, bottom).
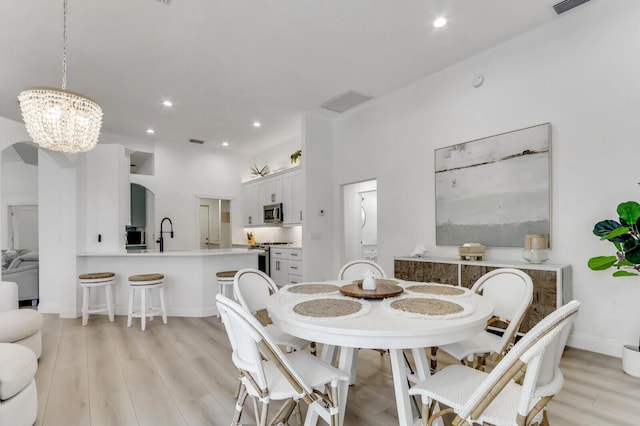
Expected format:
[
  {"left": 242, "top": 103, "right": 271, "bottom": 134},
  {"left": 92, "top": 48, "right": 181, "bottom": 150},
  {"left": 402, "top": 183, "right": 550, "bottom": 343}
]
[{"left": 242, "top": 167, "right": 304, "bottom": 226}]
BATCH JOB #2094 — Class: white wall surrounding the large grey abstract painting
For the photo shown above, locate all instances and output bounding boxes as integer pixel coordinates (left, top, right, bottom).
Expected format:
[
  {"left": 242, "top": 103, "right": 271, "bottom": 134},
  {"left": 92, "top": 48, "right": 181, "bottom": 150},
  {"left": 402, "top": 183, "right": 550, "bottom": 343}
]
[{"left": 303, "top": 0, "right": 640, "bottom": 356}]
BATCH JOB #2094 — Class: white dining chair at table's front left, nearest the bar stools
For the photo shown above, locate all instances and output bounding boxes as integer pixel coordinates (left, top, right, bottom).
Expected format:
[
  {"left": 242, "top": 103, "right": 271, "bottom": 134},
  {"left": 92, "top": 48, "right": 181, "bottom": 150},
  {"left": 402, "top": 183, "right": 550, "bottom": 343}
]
[{"left": 216, "top": 294, "right": 348, "bottom": 426}]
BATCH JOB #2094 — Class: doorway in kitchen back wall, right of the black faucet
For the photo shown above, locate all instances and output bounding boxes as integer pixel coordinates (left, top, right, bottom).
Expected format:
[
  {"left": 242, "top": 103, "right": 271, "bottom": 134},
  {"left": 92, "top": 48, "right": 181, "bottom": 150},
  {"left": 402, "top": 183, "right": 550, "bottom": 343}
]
[{"left": 198, "top": 198, "right": 231, "bottom": 249}]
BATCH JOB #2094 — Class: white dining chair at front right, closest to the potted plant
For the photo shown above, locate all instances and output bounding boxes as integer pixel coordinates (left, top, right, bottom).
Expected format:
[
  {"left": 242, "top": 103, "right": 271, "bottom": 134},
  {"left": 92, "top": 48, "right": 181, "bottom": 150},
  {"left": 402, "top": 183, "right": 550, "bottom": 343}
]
[{"left": 409, "top": 300, "right": 580, "bottom": 426}]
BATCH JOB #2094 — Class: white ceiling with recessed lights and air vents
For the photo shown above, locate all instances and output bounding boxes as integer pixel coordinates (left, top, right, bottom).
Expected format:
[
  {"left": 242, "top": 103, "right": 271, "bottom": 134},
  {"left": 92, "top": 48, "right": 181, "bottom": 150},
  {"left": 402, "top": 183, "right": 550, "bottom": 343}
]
[{"left": 0, "top": 0, "right": 588, "bottom": 152}]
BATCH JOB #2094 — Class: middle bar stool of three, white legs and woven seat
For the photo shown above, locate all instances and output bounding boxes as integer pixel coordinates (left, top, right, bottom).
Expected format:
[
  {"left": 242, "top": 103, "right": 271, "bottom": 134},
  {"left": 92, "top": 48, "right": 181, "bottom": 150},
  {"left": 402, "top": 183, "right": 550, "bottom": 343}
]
[{"left": 127, "top": 274, "right": 167, "bottom": 331}]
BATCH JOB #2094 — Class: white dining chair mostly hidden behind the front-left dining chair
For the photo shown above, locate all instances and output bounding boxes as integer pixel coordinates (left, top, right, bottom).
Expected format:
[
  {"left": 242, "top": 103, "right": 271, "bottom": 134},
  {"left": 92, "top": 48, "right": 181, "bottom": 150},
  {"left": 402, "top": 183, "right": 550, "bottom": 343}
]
[{"left": 233, "top": 268, "right": 310, "bottom": 351}]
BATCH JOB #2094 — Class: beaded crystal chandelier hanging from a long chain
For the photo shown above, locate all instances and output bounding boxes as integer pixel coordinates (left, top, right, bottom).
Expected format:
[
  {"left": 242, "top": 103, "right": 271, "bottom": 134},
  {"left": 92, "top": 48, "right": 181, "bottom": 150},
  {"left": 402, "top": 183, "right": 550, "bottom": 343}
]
[{"left": 18, "top": 0, "right": 102, "bottom": 153}]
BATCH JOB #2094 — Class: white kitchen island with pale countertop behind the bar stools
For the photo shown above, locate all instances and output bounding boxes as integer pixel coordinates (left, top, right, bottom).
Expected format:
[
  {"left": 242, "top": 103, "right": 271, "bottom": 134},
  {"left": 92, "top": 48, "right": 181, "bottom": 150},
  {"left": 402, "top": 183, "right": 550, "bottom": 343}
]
[{"left": 77, "top": 248, "right": 258, "bottom": 317}]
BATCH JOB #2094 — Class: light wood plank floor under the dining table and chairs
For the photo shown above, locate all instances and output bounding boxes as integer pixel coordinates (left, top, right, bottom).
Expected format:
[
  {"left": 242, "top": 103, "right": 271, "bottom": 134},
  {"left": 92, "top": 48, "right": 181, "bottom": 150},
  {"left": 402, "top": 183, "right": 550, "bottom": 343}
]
[{"left": 36, "top": 315, "right": 640, "bottom": 426}]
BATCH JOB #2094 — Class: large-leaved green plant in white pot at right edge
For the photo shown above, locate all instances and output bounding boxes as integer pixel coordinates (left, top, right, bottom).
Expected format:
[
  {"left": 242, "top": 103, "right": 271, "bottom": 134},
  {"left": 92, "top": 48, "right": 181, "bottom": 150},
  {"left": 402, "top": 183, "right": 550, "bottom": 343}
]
[{"left": 588, "top": 201, "right": 640, "bottom": 377}]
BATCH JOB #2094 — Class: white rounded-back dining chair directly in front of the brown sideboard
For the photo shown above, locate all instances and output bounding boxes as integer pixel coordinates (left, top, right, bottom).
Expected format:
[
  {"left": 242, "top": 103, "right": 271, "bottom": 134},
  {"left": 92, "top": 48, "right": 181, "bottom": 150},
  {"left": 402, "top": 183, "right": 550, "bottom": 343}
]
[{"left": 431, "top": 268, "right": 533, "bottom": 371}]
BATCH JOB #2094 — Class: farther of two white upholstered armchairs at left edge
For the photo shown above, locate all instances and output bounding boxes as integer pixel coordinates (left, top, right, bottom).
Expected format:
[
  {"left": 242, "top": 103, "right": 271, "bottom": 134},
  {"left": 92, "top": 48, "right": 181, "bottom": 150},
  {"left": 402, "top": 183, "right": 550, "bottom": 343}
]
[{"left": 0, "top": 281, "right": 42, "bottom": 358}]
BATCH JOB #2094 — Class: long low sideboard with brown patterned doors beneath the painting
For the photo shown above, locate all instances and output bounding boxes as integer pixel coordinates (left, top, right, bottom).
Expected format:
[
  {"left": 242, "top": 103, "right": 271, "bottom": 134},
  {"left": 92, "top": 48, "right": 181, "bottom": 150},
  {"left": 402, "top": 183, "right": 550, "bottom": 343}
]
[{"left": 393, "top": 257, "right": 572, "bottom": 333}]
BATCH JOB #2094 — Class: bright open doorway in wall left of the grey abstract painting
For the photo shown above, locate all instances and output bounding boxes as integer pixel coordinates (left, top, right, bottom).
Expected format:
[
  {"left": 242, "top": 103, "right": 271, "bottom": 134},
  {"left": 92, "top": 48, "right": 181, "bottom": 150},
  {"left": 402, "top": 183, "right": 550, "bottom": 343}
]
[{"left": 342, "top": 179, "right": 378, "bottom": 264}]
